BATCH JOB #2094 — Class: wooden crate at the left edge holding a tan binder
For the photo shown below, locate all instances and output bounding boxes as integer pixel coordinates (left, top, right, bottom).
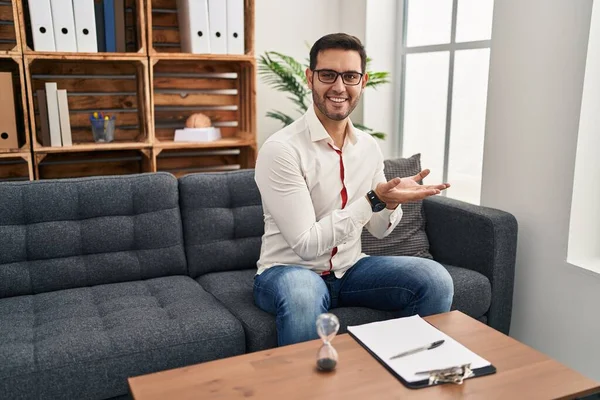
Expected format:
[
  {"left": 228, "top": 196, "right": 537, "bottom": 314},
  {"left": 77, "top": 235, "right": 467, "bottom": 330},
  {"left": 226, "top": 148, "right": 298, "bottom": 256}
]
[{"left": 0, "top": 54, "right": 30, "bottom": 154}]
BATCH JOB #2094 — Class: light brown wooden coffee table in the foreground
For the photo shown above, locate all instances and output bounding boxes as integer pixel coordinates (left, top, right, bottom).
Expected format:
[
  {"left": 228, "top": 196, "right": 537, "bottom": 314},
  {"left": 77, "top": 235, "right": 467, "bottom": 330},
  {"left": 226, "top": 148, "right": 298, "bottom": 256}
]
[{"left": 129, "top": 311, "right": 600, "bottom": 400}]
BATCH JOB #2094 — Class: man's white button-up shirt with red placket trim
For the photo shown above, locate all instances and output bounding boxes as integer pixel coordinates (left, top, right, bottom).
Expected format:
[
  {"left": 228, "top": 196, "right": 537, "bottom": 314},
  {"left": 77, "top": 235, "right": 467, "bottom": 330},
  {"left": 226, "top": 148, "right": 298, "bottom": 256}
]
[{"left": 255, "top": 105, "right": 402, "bottom": 278}]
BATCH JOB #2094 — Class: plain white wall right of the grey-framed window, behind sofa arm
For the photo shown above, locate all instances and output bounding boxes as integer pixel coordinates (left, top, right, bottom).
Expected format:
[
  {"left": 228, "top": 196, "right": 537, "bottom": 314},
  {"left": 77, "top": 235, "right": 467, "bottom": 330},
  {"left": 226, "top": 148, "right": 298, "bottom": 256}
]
[{"left": 482, "top": 0, "right": 600, "bottom": 379}]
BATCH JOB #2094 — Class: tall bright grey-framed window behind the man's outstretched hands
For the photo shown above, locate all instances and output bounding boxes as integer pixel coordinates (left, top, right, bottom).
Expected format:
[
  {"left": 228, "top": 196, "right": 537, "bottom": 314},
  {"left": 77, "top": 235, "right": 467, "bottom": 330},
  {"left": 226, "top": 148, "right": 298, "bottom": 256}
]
[{"left": 398, "top": 0, "right": 494, "bottom": 204}]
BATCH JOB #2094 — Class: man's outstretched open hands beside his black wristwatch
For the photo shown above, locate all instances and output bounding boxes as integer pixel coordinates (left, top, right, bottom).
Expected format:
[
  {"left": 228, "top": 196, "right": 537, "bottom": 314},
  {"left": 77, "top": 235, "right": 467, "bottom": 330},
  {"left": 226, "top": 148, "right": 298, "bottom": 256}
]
[{"left": 375, "top": 169, "right": 450, "bottom": 209}]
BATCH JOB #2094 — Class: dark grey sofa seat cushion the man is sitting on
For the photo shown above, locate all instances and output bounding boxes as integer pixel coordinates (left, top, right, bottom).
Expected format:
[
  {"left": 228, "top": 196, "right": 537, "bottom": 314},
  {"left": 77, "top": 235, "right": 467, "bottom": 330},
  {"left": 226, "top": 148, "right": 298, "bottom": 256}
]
[{"left": 198, "top": 266, "right": 491, "bottom": 351}]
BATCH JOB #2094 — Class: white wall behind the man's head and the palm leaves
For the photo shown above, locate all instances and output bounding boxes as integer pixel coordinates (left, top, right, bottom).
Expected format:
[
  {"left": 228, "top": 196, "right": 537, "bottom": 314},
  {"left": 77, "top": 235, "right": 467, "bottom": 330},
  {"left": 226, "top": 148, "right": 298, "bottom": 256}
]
[{"left": 256, "top": 0, "right": 398, "bottom": 157}]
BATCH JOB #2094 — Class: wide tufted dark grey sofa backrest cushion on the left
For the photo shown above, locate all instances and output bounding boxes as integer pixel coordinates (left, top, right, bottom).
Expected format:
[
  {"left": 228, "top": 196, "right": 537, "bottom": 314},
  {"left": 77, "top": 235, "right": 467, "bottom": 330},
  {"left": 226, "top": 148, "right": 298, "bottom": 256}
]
[{"left": 0, "top": 173, "right": 187, "bottom": 298}]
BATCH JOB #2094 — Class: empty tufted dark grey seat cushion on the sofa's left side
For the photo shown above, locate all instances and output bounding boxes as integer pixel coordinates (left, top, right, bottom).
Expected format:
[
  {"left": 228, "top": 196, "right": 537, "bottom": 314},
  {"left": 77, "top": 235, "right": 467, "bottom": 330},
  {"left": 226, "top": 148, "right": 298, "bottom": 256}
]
[{"left": 0, "top": 276, "right": 245, "bottom": 399}]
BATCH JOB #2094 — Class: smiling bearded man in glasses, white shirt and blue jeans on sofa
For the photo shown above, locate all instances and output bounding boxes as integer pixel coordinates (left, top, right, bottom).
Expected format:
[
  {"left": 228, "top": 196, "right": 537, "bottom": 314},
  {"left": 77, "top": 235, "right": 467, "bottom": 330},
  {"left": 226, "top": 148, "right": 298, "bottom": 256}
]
[{"left": 254, "top": 33, "right": 454, "bottom": 346}]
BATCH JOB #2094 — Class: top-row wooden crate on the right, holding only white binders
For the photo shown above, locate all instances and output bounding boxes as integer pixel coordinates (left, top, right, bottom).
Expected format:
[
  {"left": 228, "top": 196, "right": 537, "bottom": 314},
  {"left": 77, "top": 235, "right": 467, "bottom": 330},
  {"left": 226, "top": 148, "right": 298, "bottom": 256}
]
[{"left": 146, "top": 0, "right": 255, "bottom": 59}]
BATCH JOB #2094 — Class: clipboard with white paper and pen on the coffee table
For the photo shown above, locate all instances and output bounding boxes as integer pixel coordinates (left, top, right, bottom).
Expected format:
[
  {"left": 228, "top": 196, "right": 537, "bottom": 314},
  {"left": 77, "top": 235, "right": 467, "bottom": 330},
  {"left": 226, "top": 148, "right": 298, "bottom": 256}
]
[{"left": 348, "top": 315, "right": 496, "bottom": 389}]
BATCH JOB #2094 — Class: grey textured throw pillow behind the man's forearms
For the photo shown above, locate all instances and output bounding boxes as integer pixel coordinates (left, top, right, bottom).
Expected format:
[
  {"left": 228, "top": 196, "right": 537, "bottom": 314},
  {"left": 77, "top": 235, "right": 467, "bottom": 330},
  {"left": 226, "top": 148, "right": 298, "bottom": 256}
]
[{"left": 361, "top": 154, "right": 433, "bottom": 259}]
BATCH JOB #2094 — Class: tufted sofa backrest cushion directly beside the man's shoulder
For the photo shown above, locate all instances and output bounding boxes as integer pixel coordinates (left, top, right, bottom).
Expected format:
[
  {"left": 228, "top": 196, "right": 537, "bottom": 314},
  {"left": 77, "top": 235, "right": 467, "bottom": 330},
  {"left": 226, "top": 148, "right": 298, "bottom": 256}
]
[{"left": 179, "top": 170, "right": 264, "bottom": 278}]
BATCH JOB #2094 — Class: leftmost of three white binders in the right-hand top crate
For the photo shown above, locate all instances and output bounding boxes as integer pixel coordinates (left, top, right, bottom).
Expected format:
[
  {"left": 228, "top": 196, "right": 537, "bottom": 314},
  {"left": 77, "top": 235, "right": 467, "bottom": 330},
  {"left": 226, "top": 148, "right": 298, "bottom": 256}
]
[{"left": 177, "top": 0, "right": 210, "bottom": 54}]
